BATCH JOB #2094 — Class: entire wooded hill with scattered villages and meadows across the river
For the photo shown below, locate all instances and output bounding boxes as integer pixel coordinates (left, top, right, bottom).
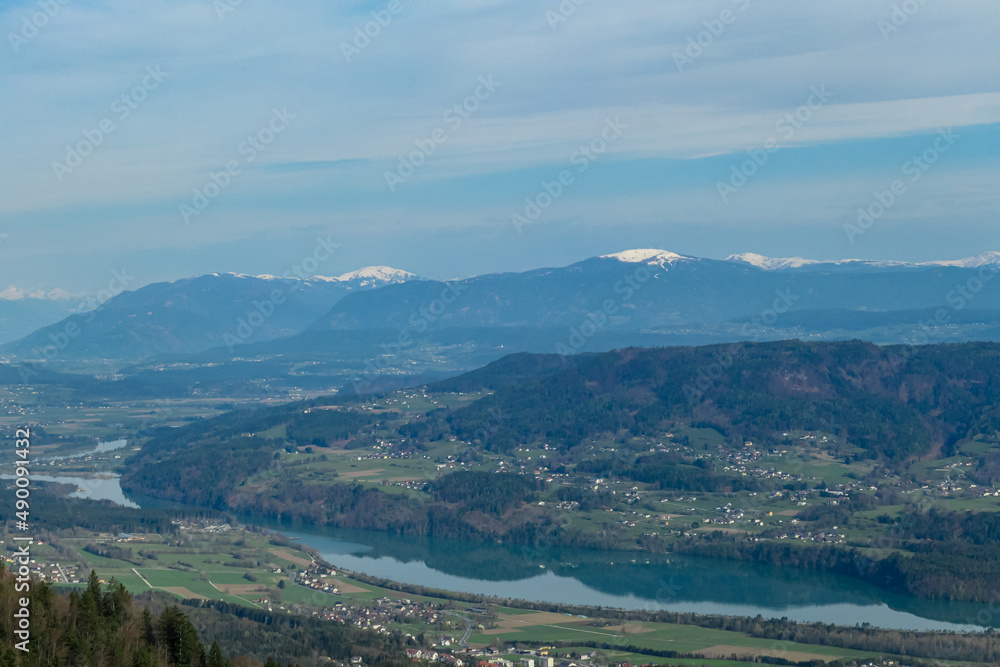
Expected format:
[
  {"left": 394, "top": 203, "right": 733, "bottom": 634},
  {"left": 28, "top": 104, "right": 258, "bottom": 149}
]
[{"left": 121, "top": 341, "right": 1000, "bottom": 600}]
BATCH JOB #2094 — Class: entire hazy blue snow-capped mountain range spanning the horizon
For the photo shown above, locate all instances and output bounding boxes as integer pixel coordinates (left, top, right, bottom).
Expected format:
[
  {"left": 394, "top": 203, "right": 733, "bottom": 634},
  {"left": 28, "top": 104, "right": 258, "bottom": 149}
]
[{"left": 0, "top": 249, "right": 1000, "bottom": 361}]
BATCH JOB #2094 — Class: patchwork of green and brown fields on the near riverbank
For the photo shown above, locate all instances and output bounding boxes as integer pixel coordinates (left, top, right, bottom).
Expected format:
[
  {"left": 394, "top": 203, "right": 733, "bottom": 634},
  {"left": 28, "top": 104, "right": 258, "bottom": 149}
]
[{"left": 25, "top": 530, "right": 916, "bottom": 665}]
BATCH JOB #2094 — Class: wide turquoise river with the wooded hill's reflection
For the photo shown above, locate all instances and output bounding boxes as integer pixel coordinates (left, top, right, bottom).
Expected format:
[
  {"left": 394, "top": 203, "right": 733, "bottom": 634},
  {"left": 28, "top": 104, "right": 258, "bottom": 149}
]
[{"left": 97, "top": 480, "right": 1000, "bottom": 631}]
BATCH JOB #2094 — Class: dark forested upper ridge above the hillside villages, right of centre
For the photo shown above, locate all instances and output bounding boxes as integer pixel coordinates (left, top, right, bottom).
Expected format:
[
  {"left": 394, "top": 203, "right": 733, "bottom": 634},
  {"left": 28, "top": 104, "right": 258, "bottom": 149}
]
[{"left": 449, "top": 341, "right": 1000, "bottom": 460}]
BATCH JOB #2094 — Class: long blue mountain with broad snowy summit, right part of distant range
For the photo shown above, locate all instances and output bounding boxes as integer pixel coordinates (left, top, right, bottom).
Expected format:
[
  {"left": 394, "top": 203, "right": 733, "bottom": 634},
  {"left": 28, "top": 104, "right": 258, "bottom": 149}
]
[{"left": 310, "top": 250, "right": 1000, "bottom": 333}]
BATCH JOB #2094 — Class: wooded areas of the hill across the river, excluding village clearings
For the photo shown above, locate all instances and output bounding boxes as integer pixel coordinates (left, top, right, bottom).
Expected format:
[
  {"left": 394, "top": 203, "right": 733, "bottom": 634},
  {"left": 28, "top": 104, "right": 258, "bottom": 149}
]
[{"left": 122, "top": 341, "right": 1000, "bottom": 601}]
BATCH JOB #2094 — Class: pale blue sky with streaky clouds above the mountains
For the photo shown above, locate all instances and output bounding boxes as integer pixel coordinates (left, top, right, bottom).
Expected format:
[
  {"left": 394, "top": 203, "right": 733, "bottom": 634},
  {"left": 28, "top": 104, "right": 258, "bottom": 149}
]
[{"left": 0, "top": 0, "right": 1000, "bottom": 293}]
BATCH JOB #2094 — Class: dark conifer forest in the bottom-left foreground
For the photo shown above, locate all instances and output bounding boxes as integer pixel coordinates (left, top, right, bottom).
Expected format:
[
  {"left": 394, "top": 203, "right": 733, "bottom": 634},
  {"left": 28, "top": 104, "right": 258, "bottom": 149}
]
[{"left": 0, "top": 566, "right": 410, "bottom": 667}]
